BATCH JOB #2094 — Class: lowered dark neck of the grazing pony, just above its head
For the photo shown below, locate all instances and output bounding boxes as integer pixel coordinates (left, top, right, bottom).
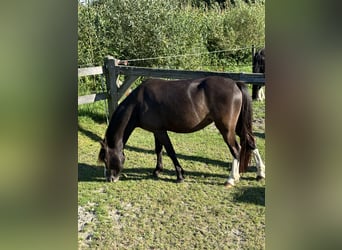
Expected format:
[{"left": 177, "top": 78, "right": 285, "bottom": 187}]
[{"left": 106, "top": 105, "right": 136, "bottom": 148}]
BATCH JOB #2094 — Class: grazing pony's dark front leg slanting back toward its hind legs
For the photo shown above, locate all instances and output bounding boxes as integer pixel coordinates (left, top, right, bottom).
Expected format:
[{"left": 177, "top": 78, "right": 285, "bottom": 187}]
[{"left": 154, "top": 131, "right": 184, "bottom": 182}]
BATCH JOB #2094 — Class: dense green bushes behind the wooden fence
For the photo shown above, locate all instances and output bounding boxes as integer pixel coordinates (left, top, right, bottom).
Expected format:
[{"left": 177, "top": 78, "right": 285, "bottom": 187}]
[{"left": 78, "top": 0, "right": 265, "bottom": 69}]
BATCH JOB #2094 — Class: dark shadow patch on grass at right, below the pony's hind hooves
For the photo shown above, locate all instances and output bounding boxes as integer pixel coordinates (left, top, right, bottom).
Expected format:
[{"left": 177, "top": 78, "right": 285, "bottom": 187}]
[{"left": 233, "top": 187, "right": 265, "bottom": 206}]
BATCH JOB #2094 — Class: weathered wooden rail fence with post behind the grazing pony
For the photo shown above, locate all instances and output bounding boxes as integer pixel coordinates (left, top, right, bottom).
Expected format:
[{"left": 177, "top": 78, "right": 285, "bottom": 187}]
[{"left": 78, "top": 56, "right": 265, "bottom": 117}]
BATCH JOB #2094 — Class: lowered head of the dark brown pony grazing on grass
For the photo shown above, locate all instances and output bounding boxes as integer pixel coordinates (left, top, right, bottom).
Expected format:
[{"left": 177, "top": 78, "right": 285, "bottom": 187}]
[{"left": 99, "top": 139, "right": 125, "bottom": 182}]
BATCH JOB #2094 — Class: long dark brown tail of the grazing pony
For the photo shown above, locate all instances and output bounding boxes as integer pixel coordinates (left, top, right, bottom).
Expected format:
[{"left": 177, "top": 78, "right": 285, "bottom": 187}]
[{"left": 236, "top": 82, "right": 256, "bottom": 173}]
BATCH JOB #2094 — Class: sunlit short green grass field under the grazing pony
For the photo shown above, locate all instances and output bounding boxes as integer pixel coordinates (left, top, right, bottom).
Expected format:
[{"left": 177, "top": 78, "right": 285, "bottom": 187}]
[{"left": 78, "top": 91, "right": 267, "bottom": 249}]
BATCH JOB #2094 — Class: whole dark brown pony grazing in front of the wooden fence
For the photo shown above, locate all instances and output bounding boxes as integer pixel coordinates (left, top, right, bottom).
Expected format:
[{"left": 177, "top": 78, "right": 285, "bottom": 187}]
[{"left": 99, "top": 77, "right": 264, "bottom": 185}]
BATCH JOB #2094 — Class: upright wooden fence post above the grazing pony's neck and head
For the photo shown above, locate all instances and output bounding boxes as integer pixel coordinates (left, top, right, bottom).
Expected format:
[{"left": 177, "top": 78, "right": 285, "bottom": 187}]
[{"left": 103, "top": 56, "right": 119, "bottom": 118}]
